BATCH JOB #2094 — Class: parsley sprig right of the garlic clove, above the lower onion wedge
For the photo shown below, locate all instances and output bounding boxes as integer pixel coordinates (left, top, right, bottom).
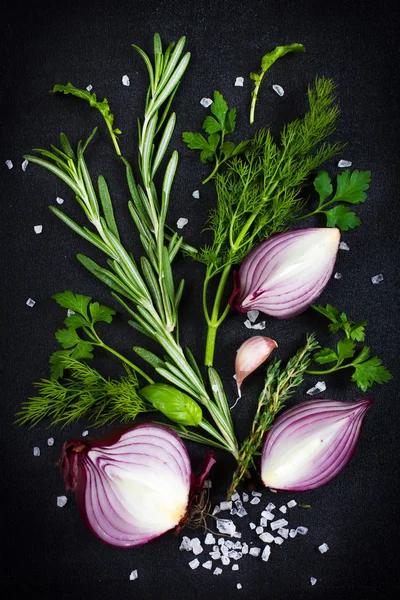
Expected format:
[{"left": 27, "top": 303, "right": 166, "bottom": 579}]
[{"left": 307, "top": 304, "right": 392, "bottom": 392}]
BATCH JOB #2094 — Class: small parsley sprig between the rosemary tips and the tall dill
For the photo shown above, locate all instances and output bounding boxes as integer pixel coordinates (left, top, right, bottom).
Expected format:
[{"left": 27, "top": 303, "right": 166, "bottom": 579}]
[{"left": 182, "top": 91, "right": 249, "bottom": 184}]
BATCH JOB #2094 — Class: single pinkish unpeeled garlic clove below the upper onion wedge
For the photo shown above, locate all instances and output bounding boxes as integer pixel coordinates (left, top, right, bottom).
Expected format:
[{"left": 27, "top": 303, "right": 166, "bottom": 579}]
[{"left": 235, "top": 335, "right": 278, "bottom": 397}]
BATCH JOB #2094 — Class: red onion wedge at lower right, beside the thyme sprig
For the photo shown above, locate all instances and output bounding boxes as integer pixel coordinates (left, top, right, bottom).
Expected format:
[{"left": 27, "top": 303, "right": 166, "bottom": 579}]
[{"left": 261, "top": 400, "right": 372, "bottom": 491}]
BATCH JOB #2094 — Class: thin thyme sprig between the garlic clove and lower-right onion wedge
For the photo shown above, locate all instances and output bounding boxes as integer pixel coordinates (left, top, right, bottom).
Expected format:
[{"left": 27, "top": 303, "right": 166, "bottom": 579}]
[{"left": 228, "top": 334, "right": 319, "bottom": 498}]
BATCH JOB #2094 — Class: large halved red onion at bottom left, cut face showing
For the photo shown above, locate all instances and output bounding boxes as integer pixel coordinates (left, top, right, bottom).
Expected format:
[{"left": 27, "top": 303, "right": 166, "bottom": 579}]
[{"left": 60, "top": 423, "right": 195, "bottom": 548}]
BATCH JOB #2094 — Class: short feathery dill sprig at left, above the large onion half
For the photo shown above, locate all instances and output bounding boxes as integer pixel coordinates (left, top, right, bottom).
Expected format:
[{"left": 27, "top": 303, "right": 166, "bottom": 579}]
[{"left": 16, "top": 356, "right": 155, "bottom": 426}]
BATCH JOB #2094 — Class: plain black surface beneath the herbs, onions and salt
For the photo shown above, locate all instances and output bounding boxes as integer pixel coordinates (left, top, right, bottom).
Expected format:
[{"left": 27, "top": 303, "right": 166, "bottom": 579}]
[{"left": 0, "top": 0, "right": 400, "bottom": 600}]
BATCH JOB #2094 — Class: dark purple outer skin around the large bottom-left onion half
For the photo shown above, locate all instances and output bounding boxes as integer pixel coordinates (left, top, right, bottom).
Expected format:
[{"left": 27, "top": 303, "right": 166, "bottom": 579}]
[{"left": 59, "top": 423, "right": 195, "bottom": 548}]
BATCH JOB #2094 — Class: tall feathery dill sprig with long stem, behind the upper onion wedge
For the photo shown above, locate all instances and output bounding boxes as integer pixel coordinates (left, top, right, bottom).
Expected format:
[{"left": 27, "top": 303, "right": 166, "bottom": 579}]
[{"left": 193, "top": 77, "right": 341, "bottom": 366}]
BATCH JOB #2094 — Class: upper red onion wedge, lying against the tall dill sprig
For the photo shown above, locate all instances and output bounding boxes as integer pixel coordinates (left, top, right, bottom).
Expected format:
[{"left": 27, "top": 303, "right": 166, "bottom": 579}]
[{"left": 230, "top": 227, "right": 340, "bottom": 319}]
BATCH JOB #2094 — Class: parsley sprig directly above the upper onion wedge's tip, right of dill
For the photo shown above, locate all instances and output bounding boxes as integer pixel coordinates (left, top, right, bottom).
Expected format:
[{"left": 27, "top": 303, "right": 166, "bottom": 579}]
[{"left": 294, "top": 170, "right": 371, "bottom": 231}]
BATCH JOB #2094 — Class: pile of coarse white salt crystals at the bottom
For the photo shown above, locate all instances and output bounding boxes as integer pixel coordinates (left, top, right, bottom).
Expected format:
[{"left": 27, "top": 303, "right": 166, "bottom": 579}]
[{"left": 179, "top": 492, "right": 328, "bottom": 589}]
